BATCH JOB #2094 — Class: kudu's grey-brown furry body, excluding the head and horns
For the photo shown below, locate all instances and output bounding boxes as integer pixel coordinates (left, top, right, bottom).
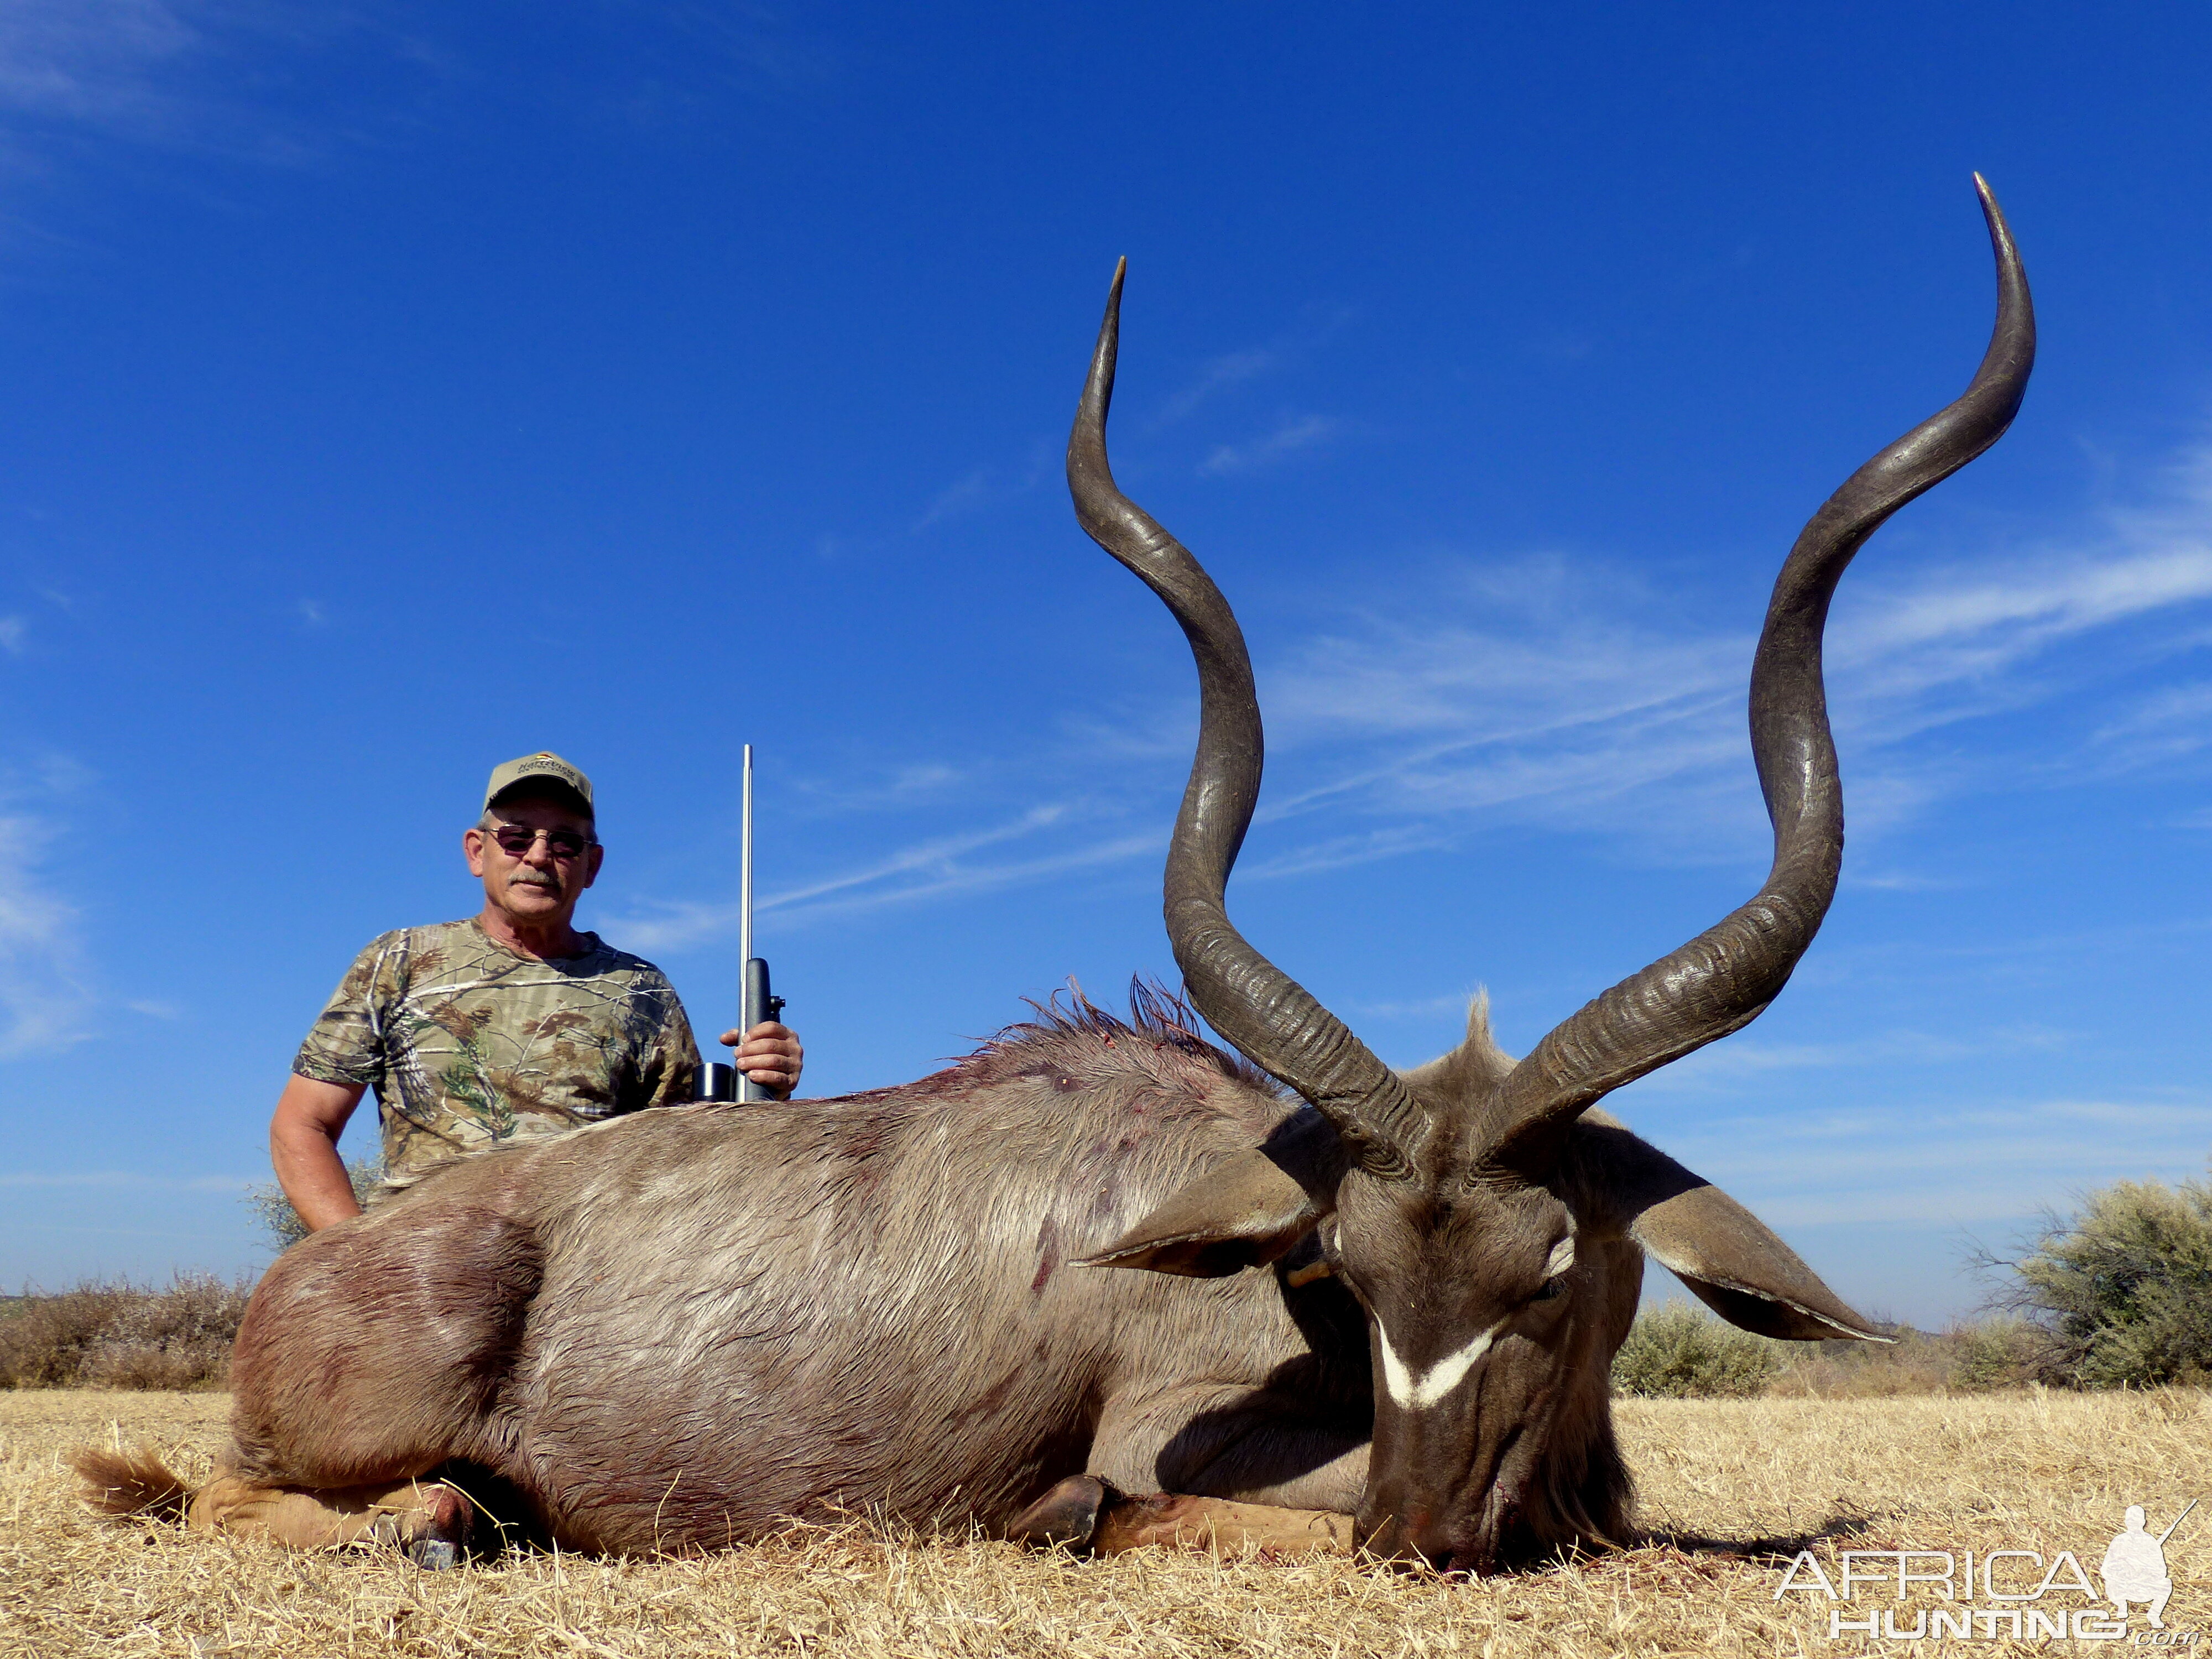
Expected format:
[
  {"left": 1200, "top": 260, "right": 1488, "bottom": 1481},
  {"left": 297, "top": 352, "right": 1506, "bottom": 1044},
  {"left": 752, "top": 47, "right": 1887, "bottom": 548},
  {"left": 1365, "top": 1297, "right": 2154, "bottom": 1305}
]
[{"left": 234, "top": 1002, "right": 1371, "bottom": 1553}]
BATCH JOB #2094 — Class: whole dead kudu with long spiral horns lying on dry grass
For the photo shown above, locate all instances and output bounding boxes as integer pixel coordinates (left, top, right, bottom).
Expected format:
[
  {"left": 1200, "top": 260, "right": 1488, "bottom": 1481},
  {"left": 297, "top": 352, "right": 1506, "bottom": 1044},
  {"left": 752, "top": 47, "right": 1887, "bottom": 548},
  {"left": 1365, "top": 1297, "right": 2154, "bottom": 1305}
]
[{"left": 93, "top": 188, "right": 2033, "bottom": 1571}]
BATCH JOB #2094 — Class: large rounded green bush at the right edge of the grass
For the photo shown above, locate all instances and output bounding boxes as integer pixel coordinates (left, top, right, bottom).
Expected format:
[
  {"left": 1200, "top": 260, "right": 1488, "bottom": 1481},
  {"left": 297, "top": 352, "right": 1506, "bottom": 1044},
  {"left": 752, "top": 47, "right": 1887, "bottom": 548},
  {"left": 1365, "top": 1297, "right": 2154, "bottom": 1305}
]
[{"left": 1982, "top": 1181, "right": 2212, "bottom": 1389}]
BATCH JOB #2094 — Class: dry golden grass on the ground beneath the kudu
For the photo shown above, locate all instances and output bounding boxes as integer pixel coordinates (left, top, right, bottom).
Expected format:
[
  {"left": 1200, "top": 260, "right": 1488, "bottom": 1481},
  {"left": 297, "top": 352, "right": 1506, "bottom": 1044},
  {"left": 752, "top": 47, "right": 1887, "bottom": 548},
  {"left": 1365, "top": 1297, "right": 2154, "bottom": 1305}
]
[{"left": 0, "top": 1389, "right": 2212, "bottom": 1659}]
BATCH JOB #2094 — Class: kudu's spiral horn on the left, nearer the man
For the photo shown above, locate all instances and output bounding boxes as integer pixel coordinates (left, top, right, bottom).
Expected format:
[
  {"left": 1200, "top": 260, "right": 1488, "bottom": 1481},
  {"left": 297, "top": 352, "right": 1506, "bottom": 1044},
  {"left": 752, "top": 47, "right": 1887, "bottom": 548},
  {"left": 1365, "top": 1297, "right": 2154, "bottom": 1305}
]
[{"left": 1068, "top": 261, "right": 1429, "bottom": 1175}]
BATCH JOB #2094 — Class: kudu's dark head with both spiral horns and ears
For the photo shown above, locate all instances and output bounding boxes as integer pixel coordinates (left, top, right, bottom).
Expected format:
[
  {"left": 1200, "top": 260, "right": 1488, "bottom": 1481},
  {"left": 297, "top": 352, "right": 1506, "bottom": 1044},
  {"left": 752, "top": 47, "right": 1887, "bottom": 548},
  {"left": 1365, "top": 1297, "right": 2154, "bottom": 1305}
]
[{"left": 1068, "top": 177, "right": 2035, "bottom": 1571}]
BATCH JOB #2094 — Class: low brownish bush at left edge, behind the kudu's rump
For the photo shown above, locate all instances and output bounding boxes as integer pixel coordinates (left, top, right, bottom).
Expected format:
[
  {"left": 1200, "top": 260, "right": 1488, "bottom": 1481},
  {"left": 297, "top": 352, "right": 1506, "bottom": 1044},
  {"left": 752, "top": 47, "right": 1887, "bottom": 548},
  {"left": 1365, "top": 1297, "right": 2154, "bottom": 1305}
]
[{"left": 0, "top": 1274, "right": 252, "bottom": 1389}]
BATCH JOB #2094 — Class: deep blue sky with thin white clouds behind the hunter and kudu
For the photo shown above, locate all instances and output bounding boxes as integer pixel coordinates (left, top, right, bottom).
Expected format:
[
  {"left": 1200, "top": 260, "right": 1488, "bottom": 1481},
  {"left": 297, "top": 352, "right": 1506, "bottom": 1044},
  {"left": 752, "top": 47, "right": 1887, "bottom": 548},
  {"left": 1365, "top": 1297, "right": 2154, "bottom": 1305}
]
[{"left": 0, "top": 0, "right": 2212, "bottom": 1323}]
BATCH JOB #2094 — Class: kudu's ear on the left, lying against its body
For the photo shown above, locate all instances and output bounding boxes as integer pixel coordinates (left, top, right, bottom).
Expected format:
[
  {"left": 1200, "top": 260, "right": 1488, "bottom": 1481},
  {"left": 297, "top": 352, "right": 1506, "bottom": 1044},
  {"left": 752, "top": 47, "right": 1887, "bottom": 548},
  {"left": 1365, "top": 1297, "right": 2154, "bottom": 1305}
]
[{"left": 1075, "top": 1108, "right": 1345, "bottom": 1279}]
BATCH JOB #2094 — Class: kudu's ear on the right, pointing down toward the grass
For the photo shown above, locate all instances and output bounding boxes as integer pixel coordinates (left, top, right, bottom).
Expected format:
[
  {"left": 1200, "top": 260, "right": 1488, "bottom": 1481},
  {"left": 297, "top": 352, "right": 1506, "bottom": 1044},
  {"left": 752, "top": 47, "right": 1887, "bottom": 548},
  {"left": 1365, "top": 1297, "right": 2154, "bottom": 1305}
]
[{"left": 1564, "top": 1110, "right": 1889, "bottom": 1343}]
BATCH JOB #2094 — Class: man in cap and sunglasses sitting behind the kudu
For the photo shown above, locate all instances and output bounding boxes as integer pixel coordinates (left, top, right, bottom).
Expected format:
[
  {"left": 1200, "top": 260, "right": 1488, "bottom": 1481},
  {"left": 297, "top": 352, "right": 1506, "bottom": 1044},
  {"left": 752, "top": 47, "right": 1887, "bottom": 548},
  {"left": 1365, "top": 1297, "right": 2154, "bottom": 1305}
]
[{"left": 270, "top": 752, "right": 805, "bottom": 1232}]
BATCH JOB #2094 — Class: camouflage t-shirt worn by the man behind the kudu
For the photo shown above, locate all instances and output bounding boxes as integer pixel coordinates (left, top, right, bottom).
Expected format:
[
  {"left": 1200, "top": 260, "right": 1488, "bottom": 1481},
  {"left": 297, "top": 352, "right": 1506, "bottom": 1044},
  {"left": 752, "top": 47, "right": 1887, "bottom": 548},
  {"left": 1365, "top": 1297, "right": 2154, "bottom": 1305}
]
[{"left": 292, "top": 918, "right": 699, "bottom": 1186}]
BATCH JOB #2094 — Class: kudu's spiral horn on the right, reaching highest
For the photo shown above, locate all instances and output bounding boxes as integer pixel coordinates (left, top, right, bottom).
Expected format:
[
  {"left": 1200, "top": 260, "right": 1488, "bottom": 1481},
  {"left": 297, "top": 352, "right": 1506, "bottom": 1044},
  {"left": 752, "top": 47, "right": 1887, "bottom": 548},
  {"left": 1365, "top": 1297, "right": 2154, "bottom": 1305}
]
[{"left": 1478, "top": 175, "right": 2035, "bottom": 1168}]
